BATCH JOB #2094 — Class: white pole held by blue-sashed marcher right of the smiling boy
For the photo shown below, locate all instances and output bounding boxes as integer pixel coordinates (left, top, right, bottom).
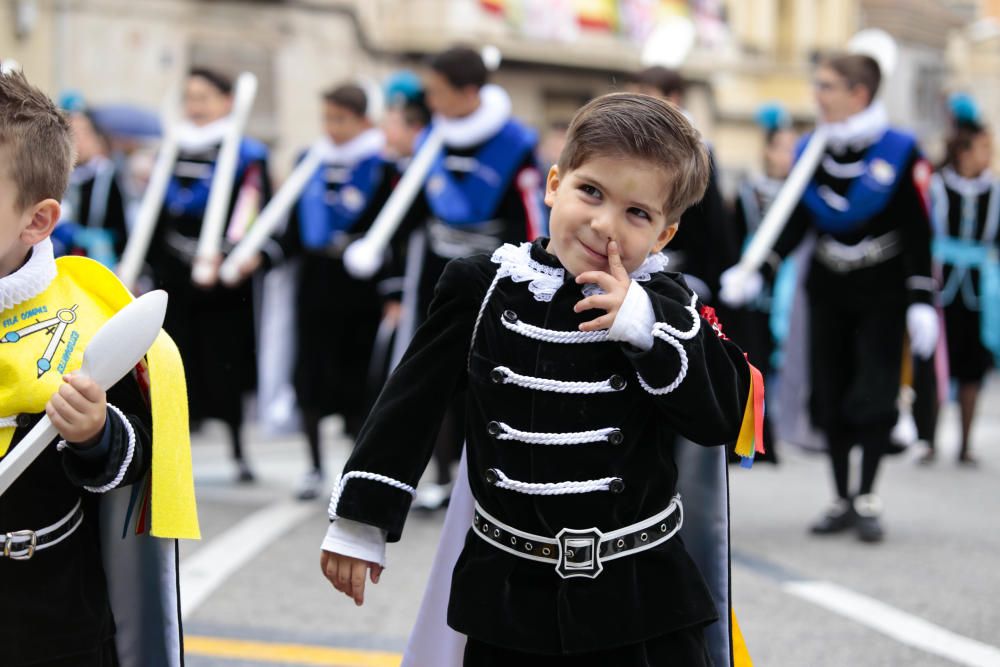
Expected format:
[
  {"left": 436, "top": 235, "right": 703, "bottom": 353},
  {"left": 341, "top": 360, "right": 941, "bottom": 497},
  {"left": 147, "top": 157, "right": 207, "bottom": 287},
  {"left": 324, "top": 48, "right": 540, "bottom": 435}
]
[{"left": 737, "top": 126, "right": 826, "bottom": 275}]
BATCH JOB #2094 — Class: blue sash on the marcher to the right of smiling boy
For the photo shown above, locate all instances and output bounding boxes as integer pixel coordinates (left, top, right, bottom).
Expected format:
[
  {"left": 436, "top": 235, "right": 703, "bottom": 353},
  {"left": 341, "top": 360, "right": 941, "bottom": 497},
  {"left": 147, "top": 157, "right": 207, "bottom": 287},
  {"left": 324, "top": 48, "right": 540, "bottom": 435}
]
[{"left": 796, "top": 129, "right": 916, "bottom": 233}]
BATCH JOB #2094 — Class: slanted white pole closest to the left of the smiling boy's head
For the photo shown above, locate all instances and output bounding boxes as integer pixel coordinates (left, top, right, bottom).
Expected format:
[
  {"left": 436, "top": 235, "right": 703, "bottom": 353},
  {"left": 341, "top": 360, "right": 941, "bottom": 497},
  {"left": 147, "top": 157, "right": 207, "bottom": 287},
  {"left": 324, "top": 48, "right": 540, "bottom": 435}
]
[{"left": 344, "top": 129, "right": 444, "bottom": 279}]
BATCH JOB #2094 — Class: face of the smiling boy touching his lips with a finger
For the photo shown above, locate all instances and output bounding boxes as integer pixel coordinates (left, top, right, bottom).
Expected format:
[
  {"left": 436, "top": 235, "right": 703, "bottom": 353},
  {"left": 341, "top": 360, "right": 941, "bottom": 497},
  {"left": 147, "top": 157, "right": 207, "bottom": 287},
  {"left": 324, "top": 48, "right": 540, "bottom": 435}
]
[{"left": 545, "top": 157, "right": 677, "bottom": 275}]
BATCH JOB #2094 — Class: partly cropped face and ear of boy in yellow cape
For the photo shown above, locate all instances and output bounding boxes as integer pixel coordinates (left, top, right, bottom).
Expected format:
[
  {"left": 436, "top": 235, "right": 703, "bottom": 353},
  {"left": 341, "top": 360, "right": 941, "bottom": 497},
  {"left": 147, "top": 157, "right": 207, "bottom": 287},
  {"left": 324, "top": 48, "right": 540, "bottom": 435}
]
[{"left": 0, "top": 147, "right": 59, "bottom": 278}]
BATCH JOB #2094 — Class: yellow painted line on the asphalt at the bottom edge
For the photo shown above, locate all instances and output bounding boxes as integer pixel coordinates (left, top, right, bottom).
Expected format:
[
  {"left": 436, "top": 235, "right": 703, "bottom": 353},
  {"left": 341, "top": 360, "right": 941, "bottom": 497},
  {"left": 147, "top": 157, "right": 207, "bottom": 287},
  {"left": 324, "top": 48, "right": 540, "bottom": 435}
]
[{"left": 184, "top": 636, "right": 403, "bottom": 667}]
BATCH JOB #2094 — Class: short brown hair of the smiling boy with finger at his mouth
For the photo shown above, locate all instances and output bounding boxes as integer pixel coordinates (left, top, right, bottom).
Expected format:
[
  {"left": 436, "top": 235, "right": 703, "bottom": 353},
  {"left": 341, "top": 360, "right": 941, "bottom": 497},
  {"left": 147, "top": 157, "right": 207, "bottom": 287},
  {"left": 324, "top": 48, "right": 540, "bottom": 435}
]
[{"left": 558, "top": 93, "right": 711, "bottom": 223}]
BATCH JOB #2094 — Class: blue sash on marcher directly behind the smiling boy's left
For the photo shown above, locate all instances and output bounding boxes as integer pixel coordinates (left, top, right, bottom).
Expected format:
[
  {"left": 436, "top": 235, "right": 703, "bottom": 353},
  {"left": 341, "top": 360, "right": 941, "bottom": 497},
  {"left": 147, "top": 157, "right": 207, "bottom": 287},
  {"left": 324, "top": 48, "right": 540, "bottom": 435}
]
[{"left": 421, "top": 120, "right": 538, "bottom": 227}]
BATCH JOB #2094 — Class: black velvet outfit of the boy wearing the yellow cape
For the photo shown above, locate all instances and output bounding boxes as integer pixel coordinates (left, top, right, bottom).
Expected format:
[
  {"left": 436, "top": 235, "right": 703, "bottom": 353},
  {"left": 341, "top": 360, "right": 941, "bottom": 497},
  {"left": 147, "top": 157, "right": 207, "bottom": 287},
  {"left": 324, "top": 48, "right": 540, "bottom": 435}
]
[{"left": 0, "top": 375, "right": 152, "bottom": 667}]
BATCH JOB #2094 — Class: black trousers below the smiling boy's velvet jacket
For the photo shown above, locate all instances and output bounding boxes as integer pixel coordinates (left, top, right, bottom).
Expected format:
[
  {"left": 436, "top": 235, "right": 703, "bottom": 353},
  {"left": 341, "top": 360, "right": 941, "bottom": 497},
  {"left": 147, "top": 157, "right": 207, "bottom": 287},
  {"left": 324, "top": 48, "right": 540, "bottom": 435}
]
[{"left": 463, "top": 628, "right": 712, "bottom": 667}]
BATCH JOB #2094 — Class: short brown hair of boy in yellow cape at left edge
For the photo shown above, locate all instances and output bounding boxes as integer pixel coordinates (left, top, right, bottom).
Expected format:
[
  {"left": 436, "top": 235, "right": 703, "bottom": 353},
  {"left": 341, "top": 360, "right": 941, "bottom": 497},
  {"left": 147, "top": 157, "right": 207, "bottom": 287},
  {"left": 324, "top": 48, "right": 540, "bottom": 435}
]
[{"left": 0, "top": 71, "right": 73, "bottom": 211}]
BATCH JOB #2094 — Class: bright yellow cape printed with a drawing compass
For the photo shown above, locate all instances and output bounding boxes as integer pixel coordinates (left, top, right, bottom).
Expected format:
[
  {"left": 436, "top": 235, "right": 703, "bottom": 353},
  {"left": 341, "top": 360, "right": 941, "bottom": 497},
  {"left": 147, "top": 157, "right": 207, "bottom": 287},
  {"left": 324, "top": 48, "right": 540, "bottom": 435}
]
[{"left": 0, "top": 257, "right": 200, "bottom": 539}]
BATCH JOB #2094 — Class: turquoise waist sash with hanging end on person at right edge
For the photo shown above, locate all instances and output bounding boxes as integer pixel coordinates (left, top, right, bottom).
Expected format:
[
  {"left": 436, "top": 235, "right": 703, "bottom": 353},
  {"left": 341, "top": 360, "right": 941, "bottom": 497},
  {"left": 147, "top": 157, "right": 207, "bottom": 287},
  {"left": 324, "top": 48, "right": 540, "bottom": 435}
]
[{"left": 933, "top": 236, "right": 1000, "bottom": 359}]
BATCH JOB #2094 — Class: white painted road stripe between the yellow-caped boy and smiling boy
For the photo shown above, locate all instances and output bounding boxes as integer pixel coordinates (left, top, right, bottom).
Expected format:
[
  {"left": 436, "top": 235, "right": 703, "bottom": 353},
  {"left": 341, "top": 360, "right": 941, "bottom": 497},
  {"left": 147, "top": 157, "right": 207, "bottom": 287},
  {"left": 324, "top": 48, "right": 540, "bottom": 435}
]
[{"left": 181, "top": 500, "right": 316, "bottom": 618}]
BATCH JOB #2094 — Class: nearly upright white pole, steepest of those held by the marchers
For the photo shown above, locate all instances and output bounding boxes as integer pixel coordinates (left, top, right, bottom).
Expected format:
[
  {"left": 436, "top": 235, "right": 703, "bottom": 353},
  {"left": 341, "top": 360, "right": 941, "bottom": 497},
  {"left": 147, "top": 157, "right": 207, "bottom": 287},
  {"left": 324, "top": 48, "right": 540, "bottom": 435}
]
[{"left": 191, "top": 72, "right": 257, "bottom": 286}]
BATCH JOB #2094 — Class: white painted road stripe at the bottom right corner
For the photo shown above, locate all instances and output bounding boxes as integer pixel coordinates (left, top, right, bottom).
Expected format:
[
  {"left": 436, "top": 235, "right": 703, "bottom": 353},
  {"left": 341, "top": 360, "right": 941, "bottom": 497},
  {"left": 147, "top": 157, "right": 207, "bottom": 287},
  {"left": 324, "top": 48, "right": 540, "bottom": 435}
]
[{"left": 781, "top": 581, "right": 1000, "bottom": 667}]
